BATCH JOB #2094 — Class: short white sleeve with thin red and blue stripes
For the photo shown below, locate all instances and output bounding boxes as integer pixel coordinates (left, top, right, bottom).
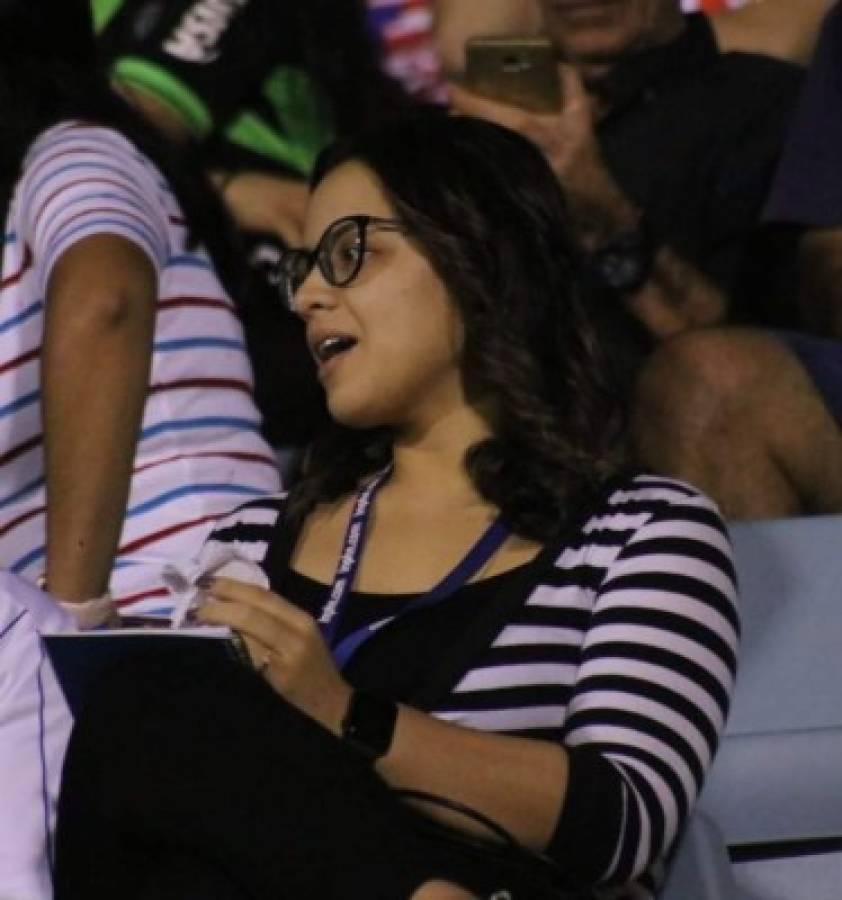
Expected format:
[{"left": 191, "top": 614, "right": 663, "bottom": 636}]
[{"left": 19, "top": 124, "right": 170, "bottom": 289}]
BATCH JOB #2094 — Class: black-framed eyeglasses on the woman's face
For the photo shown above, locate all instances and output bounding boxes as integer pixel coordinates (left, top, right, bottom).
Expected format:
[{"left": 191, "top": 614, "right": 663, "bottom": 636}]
[{"left": 278, "top": 215, "right": 405, "bottom": 312}]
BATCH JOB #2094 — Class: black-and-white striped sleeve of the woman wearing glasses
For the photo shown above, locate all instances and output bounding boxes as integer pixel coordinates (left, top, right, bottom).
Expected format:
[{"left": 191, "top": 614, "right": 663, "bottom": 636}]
[{"left": 555, "top": 490, "right": 739, "bottom": 884}]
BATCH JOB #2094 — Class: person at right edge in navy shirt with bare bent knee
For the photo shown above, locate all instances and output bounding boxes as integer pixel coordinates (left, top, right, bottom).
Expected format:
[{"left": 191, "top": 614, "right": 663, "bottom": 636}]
[{"left": 641, "top": 3, "right": 842, "bottom": 518}]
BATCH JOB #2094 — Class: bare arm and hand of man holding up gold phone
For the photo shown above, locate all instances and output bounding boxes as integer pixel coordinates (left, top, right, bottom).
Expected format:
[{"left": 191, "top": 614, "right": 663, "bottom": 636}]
[{"left": 452, "top": 66, "right": 727, "bottom": 339}]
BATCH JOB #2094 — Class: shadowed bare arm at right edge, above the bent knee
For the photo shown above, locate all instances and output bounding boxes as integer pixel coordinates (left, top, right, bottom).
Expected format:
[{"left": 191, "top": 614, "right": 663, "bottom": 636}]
[{"left": 799, "top": 227, "right": 842, "bottom": 340}]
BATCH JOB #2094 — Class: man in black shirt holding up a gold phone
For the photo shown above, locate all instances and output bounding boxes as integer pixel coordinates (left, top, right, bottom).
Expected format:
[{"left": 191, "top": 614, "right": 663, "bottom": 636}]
[{"left": 453, "top": 0, "right": 801, "bottom": 340}]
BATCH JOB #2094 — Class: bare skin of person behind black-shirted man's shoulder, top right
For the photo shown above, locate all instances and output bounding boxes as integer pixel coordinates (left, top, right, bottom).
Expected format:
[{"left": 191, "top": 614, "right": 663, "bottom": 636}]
[{"left": 710, "top": 0, "right": 834, "bottom": 65}]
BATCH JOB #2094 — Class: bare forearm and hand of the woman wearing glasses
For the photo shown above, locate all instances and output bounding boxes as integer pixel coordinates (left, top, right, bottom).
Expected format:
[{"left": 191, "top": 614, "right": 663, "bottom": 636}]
[{"left": 198, "top": 578, "right": 567, "bottom": 850}]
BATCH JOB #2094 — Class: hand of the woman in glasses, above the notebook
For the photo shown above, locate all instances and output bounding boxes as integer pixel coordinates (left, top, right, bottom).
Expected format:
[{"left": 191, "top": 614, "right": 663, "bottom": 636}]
[{"left": 196, "top": 578, "right": 351, "bottom": 735}]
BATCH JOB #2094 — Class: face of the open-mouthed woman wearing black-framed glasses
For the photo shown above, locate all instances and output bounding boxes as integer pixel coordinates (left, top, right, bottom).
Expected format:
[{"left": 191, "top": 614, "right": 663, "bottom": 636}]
[{"left": 295, "top": 161, "right": 465, "bottom": 430}]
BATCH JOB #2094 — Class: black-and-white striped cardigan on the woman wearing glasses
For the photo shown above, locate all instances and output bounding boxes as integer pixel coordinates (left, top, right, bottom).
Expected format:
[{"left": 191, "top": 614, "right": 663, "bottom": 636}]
[{"left": 210, "top": 475, "right": 739, "bottom": 900}]
